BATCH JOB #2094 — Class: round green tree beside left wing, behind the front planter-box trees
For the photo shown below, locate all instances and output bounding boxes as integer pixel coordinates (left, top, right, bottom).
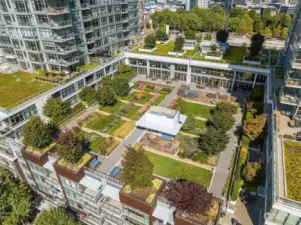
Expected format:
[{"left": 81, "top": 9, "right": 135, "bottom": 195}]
[{"left": 43, "top": 98, "right": 71, "bottom": 124}]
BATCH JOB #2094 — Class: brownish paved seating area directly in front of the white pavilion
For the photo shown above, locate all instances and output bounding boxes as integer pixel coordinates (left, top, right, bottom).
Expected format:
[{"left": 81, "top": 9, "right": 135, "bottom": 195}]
[{"left": 139, "top": 133, "right": 180, "bottom": 155}]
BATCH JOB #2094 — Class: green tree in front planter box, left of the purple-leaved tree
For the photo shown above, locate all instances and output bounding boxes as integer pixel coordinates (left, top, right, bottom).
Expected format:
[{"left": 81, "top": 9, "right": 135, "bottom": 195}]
[{"left": 123, "top": 147, "right": 154, "bottom": 190}]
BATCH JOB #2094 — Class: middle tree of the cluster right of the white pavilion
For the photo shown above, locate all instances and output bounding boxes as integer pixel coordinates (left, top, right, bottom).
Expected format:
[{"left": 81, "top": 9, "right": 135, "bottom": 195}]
[{"left": 211, "top": 112, "right": 235, "bottom": 133}]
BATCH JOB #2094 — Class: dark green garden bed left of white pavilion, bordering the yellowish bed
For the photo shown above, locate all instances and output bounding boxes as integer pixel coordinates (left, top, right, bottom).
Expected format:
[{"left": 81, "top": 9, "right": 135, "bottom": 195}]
[{"left": 87, "top": 115, "right": 125, "bottom": 134}]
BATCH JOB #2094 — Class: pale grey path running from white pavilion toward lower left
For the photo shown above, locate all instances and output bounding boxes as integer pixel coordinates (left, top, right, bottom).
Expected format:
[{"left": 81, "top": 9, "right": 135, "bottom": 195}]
[{"left": 98, "top": 128, "right": 145, "bottom": 174}]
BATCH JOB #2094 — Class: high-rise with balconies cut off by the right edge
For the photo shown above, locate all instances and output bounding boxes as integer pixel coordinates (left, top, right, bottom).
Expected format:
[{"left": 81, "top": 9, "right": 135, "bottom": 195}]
[{"left": 281, "top": 2, "right": 301, "bottom": 123}]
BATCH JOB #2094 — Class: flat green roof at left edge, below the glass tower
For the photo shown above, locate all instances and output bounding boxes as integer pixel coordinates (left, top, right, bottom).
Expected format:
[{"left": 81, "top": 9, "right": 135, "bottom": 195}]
[{"left": 0, "top": 72, "right": 55, "bottom": 108}]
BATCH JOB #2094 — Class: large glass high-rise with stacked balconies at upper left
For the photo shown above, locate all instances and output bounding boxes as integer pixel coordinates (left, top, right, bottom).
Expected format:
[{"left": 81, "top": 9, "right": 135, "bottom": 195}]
[{"left": 0, "top": 0, "right": 140, "bottom": 71}]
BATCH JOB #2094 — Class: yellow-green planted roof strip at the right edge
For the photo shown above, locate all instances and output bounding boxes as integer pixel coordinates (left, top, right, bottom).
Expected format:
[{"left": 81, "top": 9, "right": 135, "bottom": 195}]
[{"left": 283, "top": 141, "right": 301, "bottom": 202}]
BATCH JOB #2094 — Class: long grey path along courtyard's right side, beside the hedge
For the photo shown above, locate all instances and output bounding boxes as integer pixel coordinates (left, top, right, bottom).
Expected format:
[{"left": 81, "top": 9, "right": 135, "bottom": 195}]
[{"left": 209, "top": 109, "right": 242, "bottom": 199}]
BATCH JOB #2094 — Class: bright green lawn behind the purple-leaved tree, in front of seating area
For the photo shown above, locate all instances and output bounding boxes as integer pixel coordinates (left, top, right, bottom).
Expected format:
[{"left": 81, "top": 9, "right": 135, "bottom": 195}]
[{"left": 146, "top": 151, "right": 212, "bottom": 187}]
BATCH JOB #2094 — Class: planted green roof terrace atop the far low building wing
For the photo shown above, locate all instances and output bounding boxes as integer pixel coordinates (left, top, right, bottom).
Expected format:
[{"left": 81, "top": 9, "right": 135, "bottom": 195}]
[{"left": 132, "top": 41, "right": 269, "bottom": 68}]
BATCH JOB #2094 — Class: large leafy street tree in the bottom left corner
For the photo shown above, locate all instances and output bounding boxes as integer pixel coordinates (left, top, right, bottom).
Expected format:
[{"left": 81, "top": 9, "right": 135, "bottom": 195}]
[{"left": 0, "top": 168, "right": 34, "bottom": 225}]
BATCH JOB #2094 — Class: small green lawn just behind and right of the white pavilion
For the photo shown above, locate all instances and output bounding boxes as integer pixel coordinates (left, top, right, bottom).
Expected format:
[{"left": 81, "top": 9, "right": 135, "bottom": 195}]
[{"left": 176, "top": 101, "right": 213, "bottom": 119}]
